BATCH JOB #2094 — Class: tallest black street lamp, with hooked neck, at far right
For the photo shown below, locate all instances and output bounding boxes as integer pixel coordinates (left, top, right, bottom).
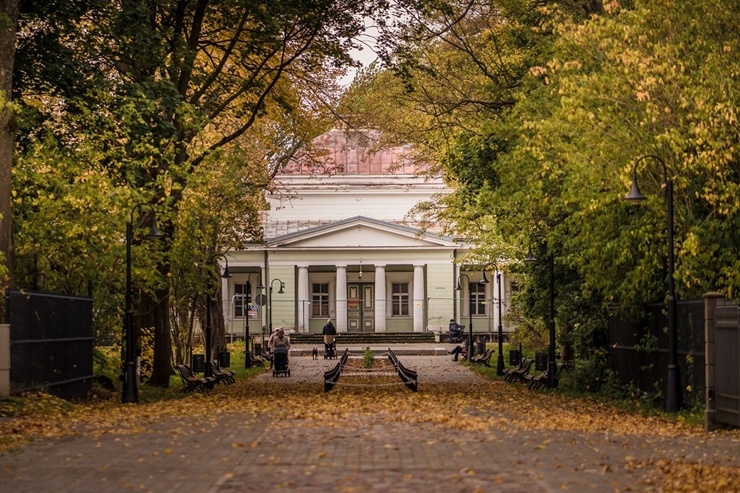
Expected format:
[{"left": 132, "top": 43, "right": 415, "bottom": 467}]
[{"left": 624, "top": 154, "right": 683, "bottom": 412}]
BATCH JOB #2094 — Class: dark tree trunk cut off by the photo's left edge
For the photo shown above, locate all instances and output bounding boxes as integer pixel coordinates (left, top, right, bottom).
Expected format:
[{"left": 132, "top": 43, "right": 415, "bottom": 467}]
[{"left": 0, "top": 0, "right": 20, "bottom": 321}]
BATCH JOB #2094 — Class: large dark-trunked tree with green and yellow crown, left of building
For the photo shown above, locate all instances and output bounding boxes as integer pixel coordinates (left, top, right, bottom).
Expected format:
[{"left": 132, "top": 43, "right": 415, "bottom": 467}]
[{"left": 11, "top": 0, "right": 394, "bottom": 385}]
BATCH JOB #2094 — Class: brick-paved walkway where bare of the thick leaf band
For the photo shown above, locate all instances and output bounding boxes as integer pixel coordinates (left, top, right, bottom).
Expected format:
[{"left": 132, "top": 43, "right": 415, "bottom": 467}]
[{"left": 0, "top": 348, "right": 740, "bottom": 493}]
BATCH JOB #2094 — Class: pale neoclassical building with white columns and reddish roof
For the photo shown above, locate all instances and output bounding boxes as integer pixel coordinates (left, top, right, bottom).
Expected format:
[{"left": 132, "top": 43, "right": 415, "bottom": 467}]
[{"left": 222, "top": 130, "right": 509, "bottom": 336}]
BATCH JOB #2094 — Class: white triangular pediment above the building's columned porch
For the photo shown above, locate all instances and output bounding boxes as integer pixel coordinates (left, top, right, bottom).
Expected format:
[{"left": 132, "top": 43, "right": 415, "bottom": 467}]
[{"left": 267, "top": 216, "right": 459, "bottom": 249}]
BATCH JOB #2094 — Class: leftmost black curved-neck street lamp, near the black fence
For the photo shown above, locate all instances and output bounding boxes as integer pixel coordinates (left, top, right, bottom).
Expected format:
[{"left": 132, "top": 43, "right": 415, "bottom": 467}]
[{"left": 121, "top": 203, "right": 162, "bottom": 403}]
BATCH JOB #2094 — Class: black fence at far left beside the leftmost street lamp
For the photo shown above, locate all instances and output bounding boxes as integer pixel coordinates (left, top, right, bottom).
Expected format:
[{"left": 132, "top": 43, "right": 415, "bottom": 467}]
[{"left": 6, "top": 291, "right": 93, "bottom": 399}]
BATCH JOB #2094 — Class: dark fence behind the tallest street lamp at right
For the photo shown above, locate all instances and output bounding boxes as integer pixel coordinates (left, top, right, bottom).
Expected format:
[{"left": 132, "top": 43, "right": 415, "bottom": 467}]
[{"left": 609, "top": 300, "right": 706, "bottom": 407}]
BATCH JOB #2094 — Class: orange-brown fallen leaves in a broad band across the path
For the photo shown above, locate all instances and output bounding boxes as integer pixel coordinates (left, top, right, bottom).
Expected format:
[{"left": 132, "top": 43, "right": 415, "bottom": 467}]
[{"left": 0, "top": 360, "right": 740, "bottom": 492}]
